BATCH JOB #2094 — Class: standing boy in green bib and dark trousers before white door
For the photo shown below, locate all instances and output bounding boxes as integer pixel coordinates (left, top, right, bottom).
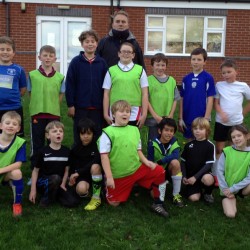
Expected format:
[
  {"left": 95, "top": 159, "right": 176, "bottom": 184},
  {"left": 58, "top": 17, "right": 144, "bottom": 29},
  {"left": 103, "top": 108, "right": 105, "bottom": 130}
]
[{"left": 28, "top": 45, "right": 65, "bottom": 169}]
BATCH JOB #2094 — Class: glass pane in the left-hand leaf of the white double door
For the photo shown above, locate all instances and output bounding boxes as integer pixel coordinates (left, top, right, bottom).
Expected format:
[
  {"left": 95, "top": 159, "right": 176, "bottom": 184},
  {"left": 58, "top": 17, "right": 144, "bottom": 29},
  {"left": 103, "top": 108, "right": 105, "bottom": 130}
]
[{"left": 41, "top": 21, "right": 60, "bottom": 60}]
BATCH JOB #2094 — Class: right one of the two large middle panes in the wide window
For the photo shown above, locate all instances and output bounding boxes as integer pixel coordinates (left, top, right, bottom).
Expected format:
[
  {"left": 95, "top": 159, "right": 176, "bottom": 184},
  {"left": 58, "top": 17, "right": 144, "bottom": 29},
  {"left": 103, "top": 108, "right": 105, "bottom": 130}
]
[{"left": 185, "top": 17, "right": 204, "bottom": 54}]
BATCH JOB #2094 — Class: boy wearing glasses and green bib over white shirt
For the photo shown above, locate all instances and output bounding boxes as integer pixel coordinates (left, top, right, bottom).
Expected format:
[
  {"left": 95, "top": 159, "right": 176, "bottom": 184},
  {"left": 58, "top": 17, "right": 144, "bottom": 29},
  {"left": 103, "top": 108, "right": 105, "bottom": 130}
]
[{"left": 103, "top": 42, "right": 148, "bottom": 128}]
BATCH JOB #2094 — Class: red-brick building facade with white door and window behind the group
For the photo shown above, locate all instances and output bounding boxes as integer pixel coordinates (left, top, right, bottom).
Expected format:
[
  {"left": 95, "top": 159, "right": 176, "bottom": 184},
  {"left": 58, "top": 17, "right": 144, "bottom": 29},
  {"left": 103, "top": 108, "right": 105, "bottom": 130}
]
[{"left": 0, "top": 0, "right": 250, "bottom": 83}]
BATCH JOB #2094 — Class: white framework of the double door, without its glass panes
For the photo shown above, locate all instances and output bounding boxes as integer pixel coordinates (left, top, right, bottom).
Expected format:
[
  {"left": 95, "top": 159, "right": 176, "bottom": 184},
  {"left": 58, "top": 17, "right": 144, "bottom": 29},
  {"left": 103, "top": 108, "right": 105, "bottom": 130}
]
[{"left": 36, "top": 16, "right": 92, "bottom": 75}]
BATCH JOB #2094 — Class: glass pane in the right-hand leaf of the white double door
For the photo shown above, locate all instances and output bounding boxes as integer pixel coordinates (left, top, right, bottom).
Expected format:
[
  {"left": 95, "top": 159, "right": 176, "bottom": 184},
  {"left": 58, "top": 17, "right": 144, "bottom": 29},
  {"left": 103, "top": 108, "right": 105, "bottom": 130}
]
[{"left": 67, "top": 22, "right": 87, "bottom": 60}]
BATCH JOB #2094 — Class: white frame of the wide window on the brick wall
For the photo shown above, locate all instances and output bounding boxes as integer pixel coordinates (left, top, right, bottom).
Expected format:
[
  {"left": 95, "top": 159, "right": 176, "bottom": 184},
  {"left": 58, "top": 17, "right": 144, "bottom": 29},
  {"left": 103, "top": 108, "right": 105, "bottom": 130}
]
[{"left": 144, "top": 15, "right": 226, "bottom": 57}]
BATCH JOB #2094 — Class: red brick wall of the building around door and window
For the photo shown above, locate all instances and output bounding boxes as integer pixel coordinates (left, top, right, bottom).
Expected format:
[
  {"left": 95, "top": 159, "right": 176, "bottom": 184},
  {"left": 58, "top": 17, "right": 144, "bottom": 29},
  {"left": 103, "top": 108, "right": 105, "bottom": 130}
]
[{"left": 0, "top": 3, "right": 250, "bottom": 83}]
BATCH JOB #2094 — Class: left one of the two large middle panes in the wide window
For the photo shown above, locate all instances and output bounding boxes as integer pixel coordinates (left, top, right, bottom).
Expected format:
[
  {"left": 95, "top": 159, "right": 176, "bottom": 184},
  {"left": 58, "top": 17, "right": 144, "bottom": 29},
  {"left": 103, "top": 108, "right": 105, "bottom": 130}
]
[{"left": 166, "top": 17, "right": 184, "bottom": 53}]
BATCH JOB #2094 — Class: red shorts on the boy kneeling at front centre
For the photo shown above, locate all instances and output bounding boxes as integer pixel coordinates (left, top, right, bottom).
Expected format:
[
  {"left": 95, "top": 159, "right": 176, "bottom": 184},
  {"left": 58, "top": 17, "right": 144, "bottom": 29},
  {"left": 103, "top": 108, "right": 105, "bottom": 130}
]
[{"left": 106, "top": 164, "right": 165, "bottom": 202}]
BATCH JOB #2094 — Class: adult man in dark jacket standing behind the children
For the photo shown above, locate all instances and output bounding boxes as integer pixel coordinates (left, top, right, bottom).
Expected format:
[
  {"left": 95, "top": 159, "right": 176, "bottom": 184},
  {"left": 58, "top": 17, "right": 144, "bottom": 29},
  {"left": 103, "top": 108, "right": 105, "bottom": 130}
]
[{"left": 96, "top": 10, "right": 145, "bottom": 69}]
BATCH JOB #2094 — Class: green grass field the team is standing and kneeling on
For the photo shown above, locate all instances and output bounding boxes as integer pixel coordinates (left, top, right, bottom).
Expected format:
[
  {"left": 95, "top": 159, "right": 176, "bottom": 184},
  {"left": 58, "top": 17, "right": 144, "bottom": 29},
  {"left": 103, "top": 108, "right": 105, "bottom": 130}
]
[{"left": 0, "top": 94, "right": 250, "bottom": 250}]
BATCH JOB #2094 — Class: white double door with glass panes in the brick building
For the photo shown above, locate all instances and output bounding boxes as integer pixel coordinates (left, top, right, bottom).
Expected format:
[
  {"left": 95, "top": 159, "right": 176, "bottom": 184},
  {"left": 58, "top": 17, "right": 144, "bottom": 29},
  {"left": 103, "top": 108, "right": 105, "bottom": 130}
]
[{"left": 36, "top": 16, "right": 91, "bottom": 75}]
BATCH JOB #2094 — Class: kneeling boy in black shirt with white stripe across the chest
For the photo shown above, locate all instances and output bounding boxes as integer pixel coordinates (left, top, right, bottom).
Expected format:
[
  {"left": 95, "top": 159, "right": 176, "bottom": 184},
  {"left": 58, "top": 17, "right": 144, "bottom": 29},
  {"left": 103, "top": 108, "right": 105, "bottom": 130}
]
[{"left": 29, "top": 121, "right": 70, "bottom": 207}]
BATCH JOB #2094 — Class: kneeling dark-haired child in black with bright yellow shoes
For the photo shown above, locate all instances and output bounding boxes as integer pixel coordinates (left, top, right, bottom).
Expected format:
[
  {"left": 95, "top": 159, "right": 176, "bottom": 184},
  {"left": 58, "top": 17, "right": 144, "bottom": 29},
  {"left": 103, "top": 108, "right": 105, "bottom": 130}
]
[{"left": 69, "top": 118, "right": 102, "bottom": 210}]
